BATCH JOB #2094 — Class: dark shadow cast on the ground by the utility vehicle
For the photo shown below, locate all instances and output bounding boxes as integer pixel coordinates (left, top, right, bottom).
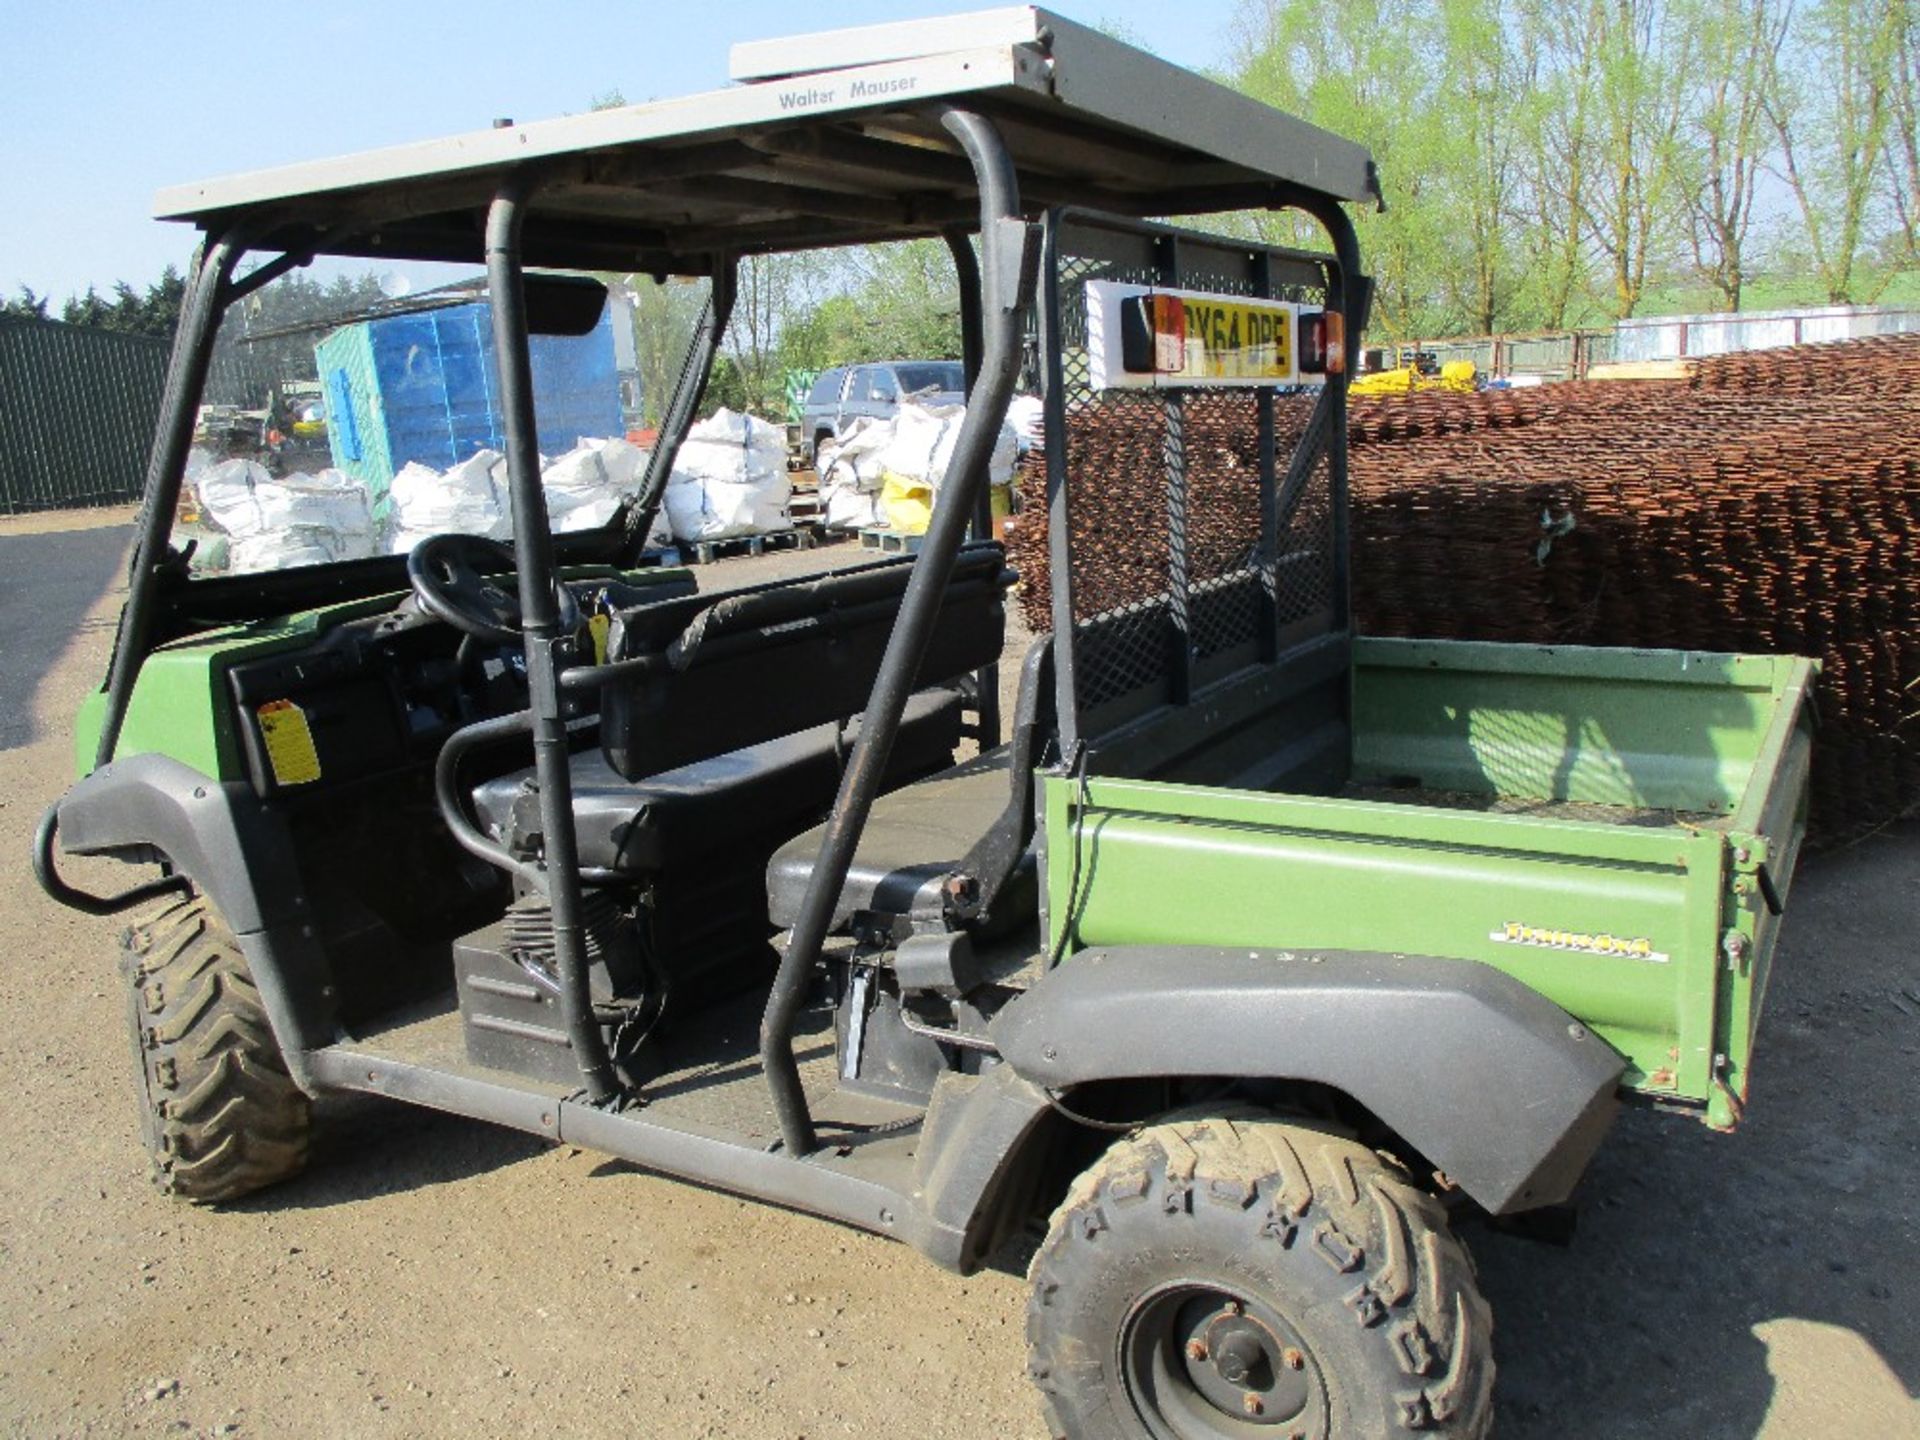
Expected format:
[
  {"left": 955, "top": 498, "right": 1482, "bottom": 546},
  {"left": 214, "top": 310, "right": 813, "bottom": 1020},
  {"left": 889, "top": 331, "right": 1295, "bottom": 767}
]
[{"left": 244, "top": 828, "right": 1920, "bottom": 1440}]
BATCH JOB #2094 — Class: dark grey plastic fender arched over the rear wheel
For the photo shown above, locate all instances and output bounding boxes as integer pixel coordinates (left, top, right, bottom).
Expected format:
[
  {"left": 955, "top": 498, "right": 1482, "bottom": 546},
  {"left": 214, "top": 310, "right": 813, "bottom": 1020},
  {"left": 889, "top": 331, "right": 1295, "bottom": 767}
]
[{"left": 991, "top": 947, "right": 1624, "bottom": 1213}]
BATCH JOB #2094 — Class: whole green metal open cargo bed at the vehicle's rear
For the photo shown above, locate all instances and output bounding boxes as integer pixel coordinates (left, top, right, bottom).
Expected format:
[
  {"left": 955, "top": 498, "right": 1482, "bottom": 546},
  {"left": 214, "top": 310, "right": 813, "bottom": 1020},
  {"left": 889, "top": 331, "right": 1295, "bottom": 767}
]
[{"left": 1044, "top": 639, "right": 1814, "bottom": 1127}]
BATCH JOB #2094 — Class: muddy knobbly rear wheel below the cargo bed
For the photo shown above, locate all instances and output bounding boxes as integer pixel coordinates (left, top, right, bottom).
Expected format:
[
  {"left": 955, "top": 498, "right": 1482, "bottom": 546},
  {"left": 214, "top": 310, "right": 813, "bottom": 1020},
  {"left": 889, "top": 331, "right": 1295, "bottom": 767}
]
[{"left": 1027, "top": 1114, "right": 1494, "bottom": 1440}]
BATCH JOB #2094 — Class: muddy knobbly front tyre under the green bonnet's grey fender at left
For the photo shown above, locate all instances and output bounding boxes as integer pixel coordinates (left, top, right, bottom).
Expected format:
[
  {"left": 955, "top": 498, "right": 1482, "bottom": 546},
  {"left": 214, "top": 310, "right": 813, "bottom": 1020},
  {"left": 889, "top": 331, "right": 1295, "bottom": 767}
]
[{"left": 121, "top": 895, "right": 311, "bottom": 1204}]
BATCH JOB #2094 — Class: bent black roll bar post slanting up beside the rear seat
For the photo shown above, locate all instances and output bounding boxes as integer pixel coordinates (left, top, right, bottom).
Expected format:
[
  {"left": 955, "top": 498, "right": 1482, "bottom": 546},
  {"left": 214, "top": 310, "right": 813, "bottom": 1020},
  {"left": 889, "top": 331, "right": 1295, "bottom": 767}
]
[{"left": 760, "top": 118, "right": 1037, "bottom": 1156}]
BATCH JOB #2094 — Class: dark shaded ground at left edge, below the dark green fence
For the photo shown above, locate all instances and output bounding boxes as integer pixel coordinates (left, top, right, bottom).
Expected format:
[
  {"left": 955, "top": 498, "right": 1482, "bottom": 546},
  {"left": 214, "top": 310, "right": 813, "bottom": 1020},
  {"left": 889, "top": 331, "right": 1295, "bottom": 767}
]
[{"left": 0, "top": 524, "right": 132, "bottom": 751}]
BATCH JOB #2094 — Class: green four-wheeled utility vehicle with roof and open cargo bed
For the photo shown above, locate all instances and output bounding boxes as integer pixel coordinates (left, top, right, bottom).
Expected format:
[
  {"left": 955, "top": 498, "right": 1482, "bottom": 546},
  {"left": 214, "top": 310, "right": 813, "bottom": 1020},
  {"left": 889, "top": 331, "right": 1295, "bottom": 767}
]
[{"left": 35, "top": 8, "right": 1812, "bottom": 1440}]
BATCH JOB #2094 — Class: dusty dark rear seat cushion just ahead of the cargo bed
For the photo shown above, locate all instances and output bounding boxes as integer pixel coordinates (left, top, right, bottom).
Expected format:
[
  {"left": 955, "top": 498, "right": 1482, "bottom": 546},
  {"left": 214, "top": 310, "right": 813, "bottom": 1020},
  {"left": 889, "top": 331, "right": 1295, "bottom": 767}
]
[{"left": 766, "top": 747, "right": 1010, "bottom": 927}]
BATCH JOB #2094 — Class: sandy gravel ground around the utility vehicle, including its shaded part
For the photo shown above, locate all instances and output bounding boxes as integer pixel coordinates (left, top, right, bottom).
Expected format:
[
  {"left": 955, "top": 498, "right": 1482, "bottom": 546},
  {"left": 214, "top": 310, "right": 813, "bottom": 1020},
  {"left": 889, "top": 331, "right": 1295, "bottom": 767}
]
[{"left": 0, "top": 524, "right": 1920, "bottom": 1440}]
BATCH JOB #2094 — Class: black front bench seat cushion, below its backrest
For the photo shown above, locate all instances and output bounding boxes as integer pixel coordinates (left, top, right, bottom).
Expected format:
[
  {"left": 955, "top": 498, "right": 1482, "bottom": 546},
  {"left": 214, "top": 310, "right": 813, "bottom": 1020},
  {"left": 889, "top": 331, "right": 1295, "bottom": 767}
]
[{"left": 472, "top": 689, "right": 960, "bottom": 877}]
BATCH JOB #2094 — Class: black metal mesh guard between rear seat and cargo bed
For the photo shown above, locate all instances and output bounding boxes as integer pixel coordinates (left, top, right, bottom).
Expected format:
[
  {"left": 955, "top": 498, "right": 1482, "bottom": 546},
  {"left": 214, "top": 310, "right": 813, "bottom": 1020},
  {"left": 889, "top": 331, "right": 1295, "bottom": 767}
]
[{"left": 1014, "top": 209, "right": 1352, "bottom": 787}]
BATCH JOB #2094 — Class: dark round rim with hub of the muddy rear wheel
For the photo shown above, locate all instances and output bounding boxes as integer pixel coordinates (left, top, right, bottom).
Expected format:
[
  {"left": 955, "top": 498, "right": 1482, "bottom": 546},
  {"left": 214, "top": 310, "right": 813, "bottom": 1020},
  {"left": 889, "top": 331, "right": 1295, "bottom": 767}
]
[{"left": 1119, "top": 1281, "right": 1327, "bottom": 1440}]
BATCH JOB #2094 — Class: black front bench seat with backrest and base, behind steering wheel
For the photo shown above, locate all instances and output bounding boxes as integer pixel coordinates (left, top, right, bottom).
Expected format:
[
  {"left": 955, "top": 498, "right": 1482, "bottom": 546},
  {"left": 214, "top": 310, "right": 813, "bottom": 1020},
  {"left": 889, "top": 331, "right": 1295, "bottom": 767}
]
[{"left": 458, "top": 543, "right": 1012, "bottom": 1008}]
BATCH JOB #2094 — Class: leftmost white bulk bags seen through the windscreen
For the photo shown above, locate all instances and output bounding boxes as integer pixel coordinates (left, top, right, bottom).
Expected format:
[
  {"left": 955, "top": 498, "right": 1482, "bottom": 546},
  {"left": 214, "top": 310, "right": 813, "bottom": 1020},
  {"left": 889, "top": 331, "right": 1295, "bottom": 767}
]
[{"left": 190, "top": 459, "right": 378, "bottom": 574}]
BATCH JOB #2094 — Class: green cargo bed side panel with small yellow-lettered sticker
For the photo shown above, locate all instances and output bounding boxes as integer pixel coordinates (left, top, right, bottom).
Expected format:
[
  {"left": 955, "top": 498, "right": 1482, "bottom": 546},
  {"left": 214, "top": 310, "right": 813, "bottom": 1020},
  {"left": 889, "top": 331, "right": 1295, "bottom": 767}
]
[{"left": 1048, "top": 780, "right": 1722, "bottom": 1098}]
